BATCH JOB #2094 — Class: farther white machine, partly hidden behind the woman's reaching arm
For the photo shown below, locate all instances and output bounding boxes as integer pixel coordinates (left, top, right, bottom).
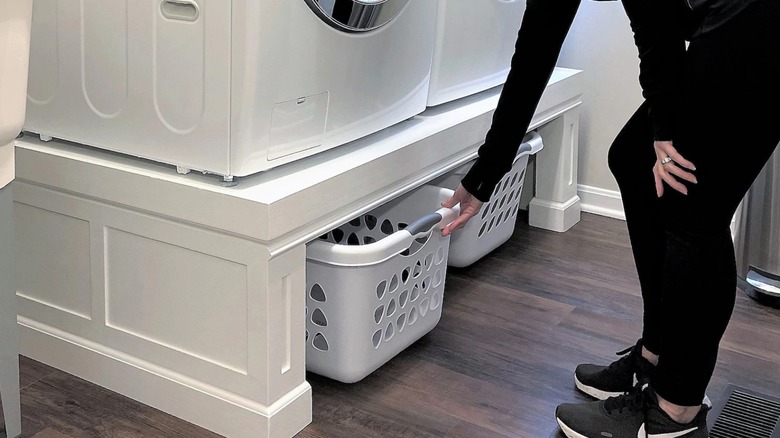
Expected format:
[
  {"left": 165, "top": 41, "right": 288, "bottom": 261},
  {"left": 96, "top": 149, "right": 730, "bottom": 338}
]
[{"left": 428, "top": 0, "right": 525, "bottom": 106}]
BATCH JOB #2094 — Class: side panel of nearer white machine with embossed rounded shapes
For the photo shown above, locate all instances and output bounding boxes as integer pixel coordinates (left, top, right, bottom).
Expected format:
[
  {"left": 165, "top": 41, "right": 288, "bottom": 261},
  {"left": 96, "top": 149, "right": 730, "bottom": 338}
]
[{"left": 25, "top": 0, "right": 231, "bottom": 174}]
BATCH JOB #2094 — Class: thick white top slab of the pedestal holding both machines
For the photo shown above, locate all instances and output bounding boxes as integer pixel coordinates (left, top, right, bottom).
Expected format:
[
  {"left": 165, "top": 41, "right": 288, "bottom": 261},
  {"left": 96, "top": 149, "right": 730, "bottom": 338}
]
[{"left": 16, "top": 68, "right": 582, "bottom": 250}]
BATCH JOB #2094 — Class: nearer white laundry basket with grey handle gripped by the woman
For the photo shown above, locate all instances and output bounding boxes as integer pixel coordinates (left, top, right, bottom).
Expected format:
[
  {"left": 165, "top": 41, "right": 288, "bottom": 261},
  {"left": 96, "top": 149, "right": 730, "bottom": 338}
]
[{"left": 306, "top": 186, "right": 458, "bottom": 383}]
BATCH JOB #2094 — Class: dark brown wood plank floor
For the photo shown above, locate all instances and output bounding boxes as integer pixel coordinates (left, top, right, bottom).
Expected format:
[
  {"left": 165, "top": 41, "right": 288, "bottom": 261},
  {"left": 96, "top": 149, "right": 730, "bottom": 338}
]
[{"left": 1, "top": 214, "right": 780, "bottom": 438}]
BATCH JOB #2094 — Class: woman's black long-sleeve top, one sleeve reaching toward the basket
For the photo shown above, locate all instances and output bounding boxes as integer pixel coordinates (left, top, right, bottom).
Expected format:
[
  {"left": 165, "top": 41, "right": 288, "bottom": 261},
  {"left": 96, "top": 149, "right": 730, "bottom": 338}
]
[{"left": 461, "top": 0, "right": 757, "bottom": 202}]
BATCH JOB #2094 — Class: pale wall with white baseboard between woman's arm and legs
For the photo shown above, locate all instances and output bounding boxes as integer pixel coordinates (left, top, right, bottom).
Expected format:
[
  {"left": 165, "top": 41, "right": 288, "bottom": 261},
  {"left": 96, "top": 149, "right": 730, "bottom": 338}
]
[{"left": 558, "top": 0, "right": 649, "bottom": 218}]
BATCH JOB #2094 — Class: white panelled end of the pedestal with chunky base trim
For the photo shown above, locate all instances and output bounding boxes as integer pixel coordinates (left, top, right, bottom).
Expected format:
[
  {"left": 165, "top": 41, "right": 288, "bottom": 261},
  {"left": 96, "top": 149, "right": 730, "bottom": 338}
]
[{"left": 14, "top": 182, "right": 310, "bottom": 437}]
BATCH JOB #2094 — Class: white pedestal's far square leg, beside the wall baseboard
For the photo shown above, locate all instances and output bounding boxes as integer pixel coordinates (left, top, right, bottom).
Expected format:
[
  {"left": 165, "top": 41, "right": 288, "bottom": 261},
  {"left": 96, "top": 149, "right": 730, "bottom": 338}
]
[{"left": 528, "top": 108, "right": 580, "bottom": 232}]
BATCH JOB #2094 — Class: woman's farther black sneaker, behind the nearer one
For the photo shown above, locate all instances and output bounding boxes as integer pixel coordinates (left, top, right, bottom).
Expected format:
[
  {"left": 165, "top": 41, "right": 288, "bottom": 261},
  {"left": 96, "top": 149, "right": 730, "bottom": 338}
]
[{"left": 574, "top": 339, "right": 654, "bottom": 400}]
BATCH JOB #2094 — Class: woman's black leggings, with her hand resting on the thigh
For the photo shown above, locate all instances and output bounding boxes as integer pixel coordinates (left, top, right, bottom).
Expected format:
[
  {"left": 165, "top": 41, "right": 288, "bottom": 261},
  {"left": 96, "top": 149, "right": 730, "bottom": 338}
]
[{"left": 609, "top": 0, "right": 780, "bottom": 406}]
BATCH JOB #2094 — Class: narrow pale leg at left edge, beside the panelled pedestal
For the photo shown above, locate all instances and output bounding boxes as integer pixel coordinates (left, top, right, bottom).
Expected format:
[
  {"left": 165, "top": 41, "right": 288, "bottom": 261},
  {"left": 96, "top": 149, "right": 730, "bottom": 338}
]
[{"left": 0, "top": 186, "right": 22, "bottom": 438}]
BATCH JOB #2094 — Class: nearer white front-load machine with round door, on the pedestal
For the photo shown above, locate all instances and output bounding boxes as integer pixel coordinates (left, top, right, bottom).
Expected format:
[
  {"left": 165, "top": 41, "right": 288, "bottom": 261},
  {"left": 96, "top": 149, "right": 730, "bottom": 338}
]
[{"left": 25, "top": 0, "right": 436, "bottom": 180}]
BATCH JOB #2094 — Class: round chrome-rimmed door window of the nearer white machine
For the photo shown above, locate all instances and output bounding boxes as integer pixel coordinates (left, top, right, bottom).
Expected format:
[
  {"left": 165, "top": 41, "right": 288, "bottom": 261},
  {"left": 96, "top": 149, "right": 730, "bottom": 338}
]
[{"left": 305, "top": 0, "right": 412, "bottom": 32}]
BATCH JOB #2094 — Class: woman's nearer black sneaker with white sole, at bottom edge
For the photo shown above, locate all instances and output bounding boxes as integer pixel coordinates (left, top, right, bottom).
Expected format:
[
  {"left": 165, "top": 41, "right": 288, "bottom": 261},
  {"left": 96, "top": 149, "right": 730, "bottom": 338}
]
[{"left": 555, "top": 384, "right": 709, "bottom": 438}]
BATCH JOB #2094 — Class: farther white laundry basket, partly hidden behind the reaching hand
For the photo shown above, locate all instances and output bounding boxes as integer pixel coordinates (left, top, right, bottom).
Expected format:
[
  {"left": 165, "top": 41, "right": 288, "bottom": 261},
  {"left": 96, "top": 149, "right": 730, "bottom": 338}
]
[{"left": 432, "top": 132, "right": 544, "bottom": 268}]
